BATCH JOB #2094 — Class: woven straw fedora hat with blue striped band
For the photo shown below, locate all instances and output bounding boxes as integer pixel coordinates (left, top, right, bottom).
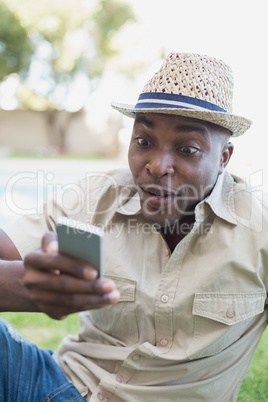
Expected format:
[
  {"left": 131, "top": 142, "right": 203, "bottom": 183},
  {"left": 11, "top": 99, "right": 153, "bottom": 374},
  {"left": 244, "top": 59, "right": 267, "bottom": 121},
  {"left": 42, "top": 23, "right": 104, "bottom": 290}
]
[{"left": 111, "top": 52, "right": 252, "bottom": 137}]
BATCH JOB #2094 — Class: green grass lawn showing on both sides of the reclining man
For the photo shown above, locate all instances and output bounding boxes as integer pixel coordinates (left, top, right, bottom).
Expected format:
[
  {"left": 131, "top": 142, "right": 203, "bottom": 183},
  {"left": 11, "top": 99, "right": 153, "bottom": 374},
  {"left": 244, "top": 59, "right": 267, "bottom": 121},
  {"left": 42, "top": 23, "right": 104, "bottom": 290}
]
[{"left": 0, "top": 313, "right": 268, "bottom": 402}]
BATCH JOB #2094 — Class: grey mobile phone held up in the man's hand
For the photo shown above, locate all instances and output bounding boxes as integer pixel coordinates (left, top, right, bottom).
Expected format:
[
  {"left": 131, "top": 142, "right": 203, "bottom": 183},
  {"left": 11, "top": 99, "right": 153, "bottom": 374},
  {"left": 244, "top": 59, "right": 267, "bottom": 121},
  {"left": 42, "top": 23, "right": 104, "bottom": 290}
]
[{"left": 56, "top": 217, "right": 104, "bottom": 277}]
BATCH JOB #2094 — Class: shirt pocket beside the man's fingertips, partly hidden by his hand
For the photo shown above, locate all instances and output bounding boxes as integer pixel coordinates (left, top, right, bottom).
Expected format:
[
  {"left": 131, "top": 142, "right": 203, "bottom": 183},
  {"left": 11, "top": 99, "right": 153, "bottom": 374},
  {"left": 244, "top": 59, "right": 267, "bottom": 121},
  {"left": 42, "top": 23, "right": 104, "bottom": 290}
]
[{"left": 90, "top": 275, "right": 138, "bottom": 346}]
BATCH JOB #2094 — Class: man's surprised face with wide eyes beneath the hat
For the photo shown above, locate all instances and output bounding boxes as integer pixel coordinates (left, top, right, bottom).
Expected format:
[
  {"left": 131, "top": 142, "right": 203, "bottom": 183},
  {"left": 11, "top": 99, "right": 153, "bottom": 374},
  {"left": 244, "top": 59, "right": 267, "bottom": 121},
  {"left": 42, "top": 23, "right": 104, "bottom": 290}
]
[{"left": 128, "top": 113, "right": 233, "bottom": 227}]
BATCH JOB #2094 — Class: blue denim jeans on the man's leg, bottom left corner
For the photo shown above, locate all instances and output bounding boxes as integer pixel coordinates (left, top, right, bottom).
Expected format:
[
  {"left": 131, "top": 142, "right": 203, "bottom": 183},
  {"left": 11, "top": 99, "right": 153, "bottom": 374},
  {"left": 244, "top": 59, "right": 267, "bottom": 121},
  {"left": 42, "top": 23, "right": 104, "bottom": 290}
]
[{"left": 0, "top": 318, "right": 85, "bottom": 402}]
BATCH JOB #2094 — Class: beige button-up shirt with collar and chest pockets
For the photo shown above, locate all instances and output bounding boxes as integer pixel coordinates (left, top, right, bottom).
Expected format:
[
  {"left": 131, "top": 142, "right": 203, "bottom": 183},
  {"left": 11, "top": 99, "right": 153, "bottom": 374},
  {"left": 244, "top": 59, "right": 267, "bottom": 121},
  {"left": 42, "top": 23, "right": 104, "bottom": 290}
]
[{"left": 2, "top": 170, "right": 268, "bottom": 402}]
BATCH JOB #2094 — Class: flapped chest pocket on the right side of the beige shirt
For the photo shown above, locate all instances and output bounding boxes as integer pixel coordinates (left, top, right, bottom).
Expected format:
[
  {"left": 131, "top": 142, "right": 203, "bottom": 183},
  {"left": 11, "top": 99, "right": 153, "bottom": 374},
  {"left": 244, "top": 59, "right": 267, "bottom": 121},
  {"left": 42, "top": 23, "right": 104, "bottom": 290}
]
[{"left": 187, "top": 291, "right": 266, "bottom": 359}]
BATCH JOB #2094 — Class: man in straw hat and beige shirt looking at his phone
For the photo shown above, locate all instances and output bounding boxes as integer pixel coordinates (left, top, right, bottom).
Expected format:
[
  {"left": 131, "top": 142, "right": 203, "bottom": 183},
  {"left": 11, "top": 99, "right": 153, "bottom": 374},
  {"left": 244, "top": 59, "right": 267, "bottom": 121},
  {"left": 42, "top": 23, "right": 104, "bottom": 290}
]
[{"left": 0, "top": 53, "right": 268, "bottom": 402}]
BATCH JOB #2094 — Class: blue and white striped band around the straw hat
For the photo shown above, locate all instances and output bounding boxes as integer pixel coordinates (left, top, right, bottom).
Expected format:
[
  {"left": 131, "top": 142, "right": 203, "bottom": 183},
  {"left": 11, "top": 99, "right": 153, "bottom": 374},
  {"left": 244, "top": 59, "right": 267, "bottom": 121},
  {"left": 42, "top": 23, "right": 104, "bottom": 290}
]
[{"left": 135, "top": 92, "right": 227, "bottom": 113}]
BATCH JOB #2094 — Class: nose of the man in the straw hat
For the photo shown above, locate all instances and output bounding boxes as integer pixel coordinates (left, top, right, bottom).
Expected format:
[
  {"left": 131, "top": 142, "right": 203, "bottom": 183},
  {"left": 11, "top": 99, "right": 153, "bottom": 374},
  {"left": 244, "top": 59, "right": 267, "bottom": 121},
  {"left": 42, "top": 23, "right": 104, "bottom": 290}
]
[{"left": 145, "top": 152, "right": 174, "bottom": 179}]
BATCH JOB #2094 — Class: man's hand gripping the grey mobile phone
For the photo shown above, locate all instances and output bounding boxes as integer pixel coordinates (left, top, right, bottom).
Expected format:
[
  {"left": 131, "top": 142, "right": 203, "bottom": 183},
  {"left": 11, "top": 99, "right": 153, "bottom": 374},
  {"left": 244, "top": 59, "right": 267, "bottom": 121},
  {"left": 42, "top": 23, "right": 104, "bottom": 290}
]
[{"left": 24, "top": 232, "right": 119, "bottom": 319}]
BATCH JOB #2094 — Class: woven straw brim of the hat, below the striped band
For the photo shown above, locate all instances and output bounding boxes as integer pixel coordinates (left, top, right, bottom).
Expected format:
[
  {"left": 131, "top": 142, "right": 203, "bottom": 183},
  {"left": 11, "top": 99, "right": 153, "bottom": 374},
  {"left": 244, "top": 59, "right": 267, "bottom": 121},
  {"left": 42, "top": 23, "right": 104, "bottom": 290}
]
[{"left": 111, "top": 102, "right": 252, "bottom": 137}]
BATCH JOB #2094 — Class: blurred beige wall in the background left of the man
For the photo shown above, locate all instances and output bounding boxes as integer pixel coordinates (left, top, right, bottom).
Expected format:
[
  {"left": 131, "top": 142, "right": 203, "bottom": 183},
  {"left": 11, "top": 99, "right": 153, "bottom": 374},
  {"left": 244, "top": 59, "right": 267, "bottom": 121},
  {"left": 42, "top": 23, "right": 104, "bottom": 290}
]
[{"left": 0, "top": 110, "right": 121, "bottom": 157}]
